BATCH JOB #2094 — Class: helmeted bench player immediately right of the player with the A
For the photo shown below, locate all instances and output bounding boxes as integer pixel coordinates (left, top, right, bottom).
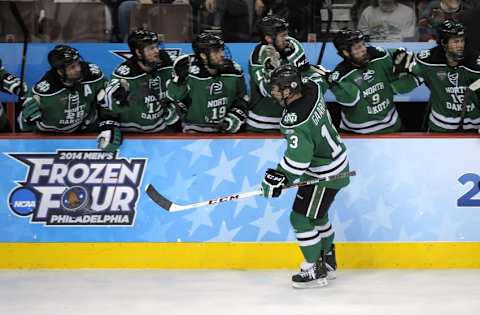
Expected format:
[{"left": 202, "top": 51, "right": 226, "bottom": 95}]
[{"left": 99, "top": 30, "right": 179, "bottom": 150}]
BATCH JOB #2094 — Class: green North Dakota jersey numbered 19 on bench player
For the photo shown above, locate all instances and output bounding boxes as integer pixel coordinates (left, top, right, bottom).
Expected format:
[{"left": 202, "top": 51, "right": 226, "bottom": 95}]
[{"left": 167, "top": 55, "right": 249, "bottom": 132}]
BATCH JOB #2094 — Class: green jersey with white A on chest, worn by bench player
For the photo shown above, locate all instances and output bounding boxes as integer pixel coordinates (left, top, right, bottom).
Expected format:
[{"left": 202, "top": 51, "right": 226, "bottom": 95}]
[{"left": 18, "top": 61, "right": 107, "bottom": 133}]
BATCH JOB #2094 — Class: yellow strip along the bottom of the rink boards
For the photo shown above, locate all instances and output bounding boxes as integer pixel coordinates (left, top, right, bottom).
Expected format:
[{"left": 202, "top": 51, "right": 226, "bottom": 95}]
[{"left": 0, "top": 242, "right": 480, "bottom": 269}]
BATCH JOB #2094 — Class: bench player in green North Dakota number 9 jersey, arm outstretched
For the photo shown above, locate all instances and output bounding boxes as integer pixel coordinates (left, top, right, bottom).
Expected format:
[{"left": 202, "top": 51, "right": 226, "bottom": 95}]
[{"left": 329, "top": 30, "right": 421, "bottom": 134}]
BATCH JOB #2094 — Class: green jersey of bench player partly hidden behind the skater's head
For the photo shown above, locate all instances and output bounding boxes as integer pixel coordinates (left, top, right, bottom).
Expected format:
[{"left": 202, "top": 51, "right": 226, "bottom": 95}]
[{"left": 246, "top": 37, "right": 309, "bottom": 132}]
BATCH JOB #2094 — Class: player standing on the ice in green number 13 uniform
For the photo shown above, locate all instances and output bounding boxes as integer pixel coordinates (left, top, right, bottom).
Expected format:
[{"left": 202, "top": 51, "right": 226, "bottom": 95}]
[{"left": 262, "top": 65, "right": 350, "bottom": 288}]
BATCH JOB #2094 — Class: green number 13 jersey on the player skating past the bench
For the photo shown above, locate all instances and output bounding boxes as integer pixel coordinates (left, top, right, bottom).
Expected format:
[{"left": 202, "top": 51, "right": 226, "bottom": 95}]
[{"left": 277, "top": 80, "right": 349, "bottom": 189}]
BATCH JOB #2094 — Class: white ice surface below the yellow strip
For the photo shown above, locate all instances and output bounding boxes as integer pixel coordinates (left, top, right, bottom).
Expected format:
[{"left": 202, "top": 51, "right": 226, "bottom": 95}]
[{"left": 0, "top": 270, "right": 480, "bottom": 315}]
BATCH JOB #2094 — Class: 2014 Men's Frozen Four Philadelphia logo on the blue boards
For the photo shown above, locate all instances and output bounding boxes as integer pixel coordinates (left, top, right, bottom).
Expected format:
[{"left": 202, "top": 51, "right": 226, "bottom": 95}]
[{"left": 8, "top": 150, "right": 147, "bottom": 226}]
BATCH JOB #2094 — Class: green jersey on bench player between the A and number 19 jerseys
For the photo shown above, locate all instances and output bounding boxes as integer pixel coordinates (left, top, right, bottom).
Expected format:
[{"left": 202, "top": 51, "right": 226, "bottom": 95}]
[{"left": 101, "top": 52, "right": 177, "bottom": 132}]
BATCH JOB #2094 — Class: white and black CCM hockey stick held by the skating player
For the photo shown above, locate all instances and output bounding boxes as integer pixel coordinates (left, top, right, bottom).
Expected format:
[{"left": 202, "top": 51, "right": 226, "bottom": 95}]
[{"left": 145, "top": 171, "right": 356, "bottom": 212}]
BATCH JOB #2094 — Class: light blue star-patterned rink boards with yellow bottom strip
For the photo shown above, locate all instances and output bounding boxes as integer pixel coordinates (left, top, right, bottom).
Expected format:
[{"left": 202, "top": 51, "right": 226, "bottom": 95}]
[{"left": 0, "top": 134, "right": 480, "bottom": 268}]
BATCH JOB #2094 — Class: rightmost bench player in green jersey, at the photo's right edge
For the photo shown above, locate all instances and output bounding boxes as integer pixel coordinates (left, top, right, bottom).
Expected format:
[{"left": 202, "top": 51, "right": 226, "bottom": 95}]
[{"left": 394, "top": 20, "right": 480, "bottom": 132}]
